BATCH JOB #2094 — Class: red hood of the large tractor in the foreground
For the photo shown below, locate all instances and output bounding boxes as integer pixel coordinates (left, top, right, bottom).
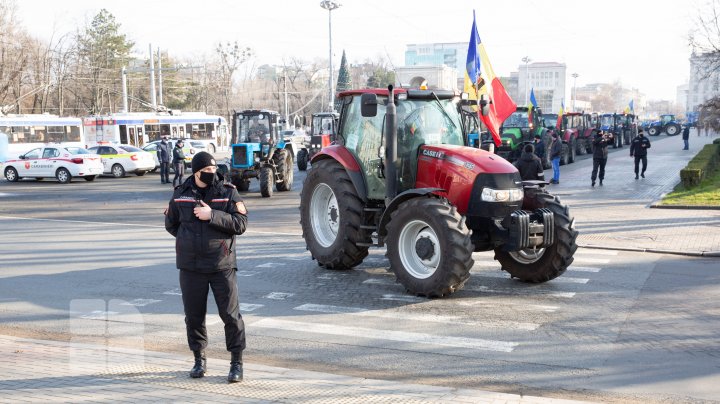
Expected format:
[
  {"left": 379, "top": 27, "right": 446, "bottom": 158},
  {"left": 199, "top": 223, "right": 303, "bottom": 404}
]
[{"left": 415, "top": 145, "right": 522, "bottom": 213}]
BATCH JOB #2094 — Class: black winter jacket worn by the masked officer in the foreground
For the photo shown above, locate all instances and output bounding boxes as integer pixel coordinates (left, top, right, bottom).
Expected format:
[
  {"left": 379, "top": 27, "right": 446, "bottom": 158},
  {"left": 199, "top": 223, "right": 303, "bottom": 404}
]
[{"left": 165, "top": 174, "right": 247, "bottom": 273}]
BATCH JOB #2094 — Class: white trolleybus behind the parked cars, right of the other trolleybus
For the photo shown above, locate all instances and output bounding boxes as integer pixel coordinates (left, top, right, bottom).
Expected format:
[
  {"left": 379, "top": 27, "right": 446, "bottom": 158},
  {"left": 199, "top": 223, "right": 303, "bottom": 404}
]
[{"left": 83, "top": 112, "right": 229, "bottom": 153}]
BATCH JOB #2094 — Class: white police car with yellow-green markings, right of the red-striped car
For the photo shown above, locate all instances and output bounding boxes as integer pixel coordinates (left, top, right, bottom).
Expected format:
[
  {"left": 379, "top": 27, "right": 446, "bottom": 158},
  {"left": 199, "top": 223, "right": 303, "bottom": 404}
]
[{"left": 88, "top": 144, "right": 155, "bottom": 178}]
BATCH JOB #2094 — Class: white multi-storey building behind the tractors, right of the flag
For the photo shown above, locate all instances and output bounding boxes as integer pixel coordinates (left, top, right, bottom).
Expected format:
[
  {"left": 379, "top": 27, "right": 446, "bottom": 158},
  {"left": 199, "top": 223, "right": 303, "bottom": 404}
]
[{"left": 514, "top": 62, "right": 571, "bottom": 113}]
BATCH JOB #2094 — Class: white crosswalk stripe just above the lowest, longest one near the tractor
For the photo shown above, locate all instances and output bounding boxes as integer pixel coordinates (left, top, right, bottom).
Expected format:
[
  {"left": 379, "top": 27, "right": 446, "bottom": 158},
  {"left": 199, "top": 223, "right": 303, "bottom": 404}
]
[{"left": 294, "top": 303, "right": 540, "bottom": 331}]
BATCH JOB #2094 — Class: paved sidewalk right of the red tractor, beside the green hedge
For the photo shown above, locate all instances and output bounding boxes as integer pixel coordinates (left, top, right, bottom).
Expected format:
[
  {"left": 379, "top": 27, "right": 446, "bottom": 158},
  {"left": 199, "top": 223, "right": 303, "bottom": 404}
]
[{"left": 545, "top": 135, "right": 720, "bottom": 257}]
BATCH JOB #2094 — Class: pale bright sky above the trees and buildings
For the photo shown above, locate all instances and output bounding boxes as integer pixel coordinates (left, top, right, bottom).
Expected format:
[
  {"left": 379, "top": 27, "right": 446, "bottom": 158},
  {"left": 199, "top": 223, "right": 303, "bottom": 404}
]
[{"left": 17, "top": 0, "right": 708, "bottom": 101}]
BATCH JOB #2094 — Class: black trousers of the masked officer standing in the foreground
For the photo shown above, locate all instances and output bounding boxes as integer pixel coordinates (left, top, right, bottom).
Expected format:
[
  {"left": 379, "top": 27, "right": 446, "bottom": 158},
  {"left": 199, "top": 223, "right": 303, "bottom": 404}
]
[{"left": 180, "top": 269, "right": 245, "bottom": 352}]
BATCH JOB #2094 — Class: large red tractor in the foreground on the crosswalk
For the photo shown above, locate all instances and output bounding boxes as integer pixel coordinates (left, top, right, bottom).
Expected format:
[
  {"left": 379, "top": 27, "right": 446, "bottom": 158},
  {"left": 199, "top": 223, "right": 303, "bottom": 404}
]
[{"left": 300, "top": 86, "right": 578, "bottom": 297}]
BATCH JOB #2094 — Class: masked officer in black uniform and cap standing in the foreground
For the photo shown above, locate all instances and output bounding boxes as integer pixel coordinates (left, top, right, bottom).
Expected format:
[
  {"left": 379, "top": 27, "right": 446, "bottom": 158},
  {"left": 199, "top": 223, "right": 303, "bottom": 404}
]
[{"left": 165, "top": 152, "right": 247, "bottom": 383}]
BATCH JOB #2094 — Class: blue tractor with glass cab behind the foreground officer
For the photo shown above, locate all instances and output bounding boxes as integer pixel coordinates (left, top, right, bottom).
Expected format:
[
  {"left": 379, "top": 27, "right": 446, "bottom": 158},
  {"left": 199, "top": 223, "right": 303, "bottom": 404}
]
[{"left": 223, "top": 109, "right": 298, "bottom": 198}]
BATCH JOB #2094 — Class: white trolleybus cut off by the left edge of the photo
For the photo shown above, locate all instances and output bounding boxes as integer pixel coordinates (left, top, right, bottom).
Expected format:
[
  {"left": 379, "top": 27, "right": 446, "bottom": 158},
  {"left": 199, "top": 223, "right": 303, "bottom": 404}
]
[{"left": 0, "top": 114, "right": 85, "bottom": 158}]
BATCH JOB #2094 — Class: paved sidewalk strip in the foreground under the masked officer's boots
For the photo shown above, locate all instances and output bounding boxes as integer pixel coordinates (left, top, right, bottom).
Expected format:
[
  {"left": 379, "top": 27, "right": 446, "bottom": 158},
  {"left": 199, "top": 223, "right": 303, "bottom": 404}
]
[{"left": 0, "top": 336, "right": 592, "bottom": 404}]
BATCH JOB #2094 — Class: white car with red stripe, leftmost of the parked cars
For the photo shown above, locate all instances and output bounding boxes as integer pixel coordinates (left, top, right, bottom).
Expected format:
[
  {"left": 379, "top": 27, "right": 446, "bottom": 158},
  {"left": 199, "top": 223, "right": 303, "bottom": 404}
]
[{"left": 4, "top": 145, "right": 103, "bottom": 184}]
